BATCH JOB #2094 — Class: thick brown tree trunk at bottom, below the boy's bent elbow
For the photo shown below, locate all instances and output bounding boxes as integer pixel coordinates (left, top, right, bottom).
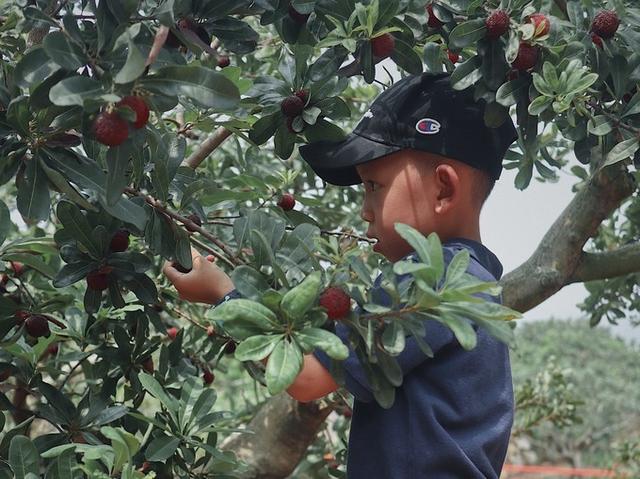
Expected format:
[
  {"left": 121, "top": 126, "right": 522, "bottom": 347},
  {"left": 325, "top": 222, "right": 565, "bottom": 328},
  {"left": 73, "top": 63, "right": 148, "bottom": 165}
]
[{"left": 222, "top": 393, "right": 333, "bottom": 479}]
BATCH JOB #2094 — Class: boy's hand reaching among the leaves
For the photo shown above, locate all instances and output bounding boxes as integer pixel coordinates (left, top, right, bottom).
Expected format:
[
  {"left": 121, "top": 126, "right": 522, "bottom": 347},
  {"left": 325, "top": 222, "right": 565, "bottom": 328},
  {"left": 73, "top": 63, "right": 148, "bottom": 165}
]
[{"left": 162, "top": 248, "right": 234, "bottom": 304}]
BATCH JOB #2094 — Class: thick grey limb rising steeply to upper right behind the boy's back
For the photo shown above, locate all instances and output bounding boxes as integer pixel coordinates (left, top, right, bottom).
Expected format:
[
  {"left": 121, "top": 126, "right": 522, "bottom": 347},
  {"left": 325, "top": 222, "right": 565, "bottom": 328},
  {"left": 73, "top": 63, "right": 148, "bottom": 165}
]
[{"left": 500, "top": 162, "right": 636, "bottom": 312}]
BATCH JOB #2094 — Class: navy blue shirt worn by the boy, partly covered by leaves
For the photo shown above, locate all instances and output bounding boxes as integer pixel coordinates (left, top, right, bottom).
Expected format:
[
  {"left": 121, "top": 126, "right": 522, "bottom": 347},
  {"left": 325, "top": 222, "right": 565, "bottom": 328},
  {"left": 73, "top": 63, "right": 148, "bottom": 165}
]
[{"left": 313, "top": 238, "right": 514, "bottom": 479}]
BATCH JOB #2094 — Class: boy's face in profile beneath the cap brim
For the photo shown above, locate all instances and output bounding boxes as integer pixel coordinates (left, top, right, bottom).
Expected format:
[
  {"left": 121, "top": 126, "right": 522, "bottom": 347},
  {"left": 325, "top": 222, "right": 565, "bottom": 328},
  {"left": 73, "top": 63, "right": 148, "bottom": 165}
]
[{"left": 356, "top": 150, "right": 458, "bottom": 261}]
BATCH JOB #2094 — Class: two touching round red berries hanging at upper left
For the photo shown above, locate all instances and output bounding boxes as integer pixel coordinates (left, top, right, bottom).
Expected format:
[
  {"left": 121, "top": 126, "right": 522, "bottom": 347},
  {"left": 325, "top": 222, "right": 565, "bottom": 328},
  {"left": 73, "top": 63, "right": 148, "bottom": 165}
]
[{"left": 93, "top": 95, "right": 149, "bottom": 146}]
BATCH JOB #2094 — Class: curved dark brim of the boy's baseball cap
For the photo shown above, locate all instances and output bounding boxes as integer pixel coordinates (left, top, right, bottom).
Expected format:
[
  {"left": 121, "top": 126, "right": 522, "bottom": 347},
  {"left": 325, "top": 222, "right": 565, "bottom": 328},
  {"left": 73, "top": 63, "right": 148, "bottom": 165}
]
[{"left": 300, "top": 133, "right": 403, "bottom": 186}]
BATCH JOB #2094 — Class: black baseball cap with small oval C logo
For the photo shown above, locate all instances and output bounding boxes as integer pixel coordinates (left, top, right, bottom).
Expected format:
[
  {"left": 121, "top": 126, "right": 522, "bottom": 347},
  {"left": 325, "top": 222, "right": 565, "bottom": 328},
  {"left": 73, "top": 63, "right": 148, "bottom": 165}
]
[{"left": 300, "top": 73, "right": 518, "bottom": 186}]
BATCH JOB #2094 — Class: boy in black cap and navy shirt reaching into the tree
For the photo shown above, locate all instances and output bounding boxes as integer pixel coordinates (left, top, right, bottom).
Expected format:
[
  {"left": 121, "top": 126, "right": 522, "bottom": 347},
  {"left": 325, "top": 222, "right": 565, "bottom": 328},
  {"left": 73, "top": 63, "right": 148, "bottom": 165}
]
[{"left": 165, "top": 73, "right": 517, "bottom": 479}]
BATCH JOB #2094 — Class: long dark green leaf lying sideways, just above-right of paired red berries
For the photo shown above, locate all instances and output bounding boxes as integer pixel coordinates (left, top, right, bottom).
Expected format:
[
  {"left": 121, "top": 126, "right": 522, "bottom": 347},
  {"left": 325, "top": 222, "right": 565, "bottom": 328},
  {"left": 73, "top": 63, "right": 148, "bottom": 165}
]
[{"left": 140, "top": 65, "right": 240, "bottom": 110}]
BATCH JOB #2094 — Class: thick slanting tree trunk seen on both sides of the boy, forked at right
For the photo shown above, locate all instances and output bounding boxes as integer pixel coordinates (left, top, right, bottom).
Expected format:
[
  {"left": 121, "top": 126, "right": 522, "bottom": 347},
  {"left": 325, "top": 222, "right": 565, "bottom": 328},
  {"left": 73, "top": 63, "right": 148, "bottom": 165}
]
[{"left": 219, "top": 162, "right": 640, "bottom": 479}]
